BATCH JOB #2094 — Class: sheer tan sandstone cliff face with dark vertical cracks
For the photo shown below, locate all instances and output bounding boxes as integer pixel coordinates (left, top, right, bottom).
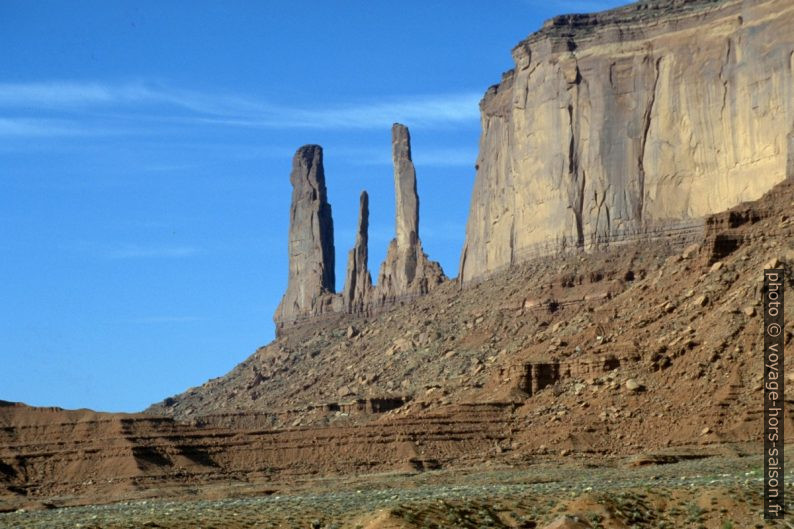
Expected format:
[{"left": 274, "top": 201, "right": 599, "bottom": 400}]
[{"left": 460, "top": 0, "right": 794, "bottom": 281}]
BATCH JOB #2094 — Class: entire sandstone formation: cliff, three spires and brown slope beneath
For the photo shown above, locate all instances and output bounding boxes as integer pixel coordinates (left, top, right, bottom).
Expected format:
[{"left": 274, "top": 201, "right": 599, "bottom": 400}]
[{"left": 0, "top": 0, "right": 794, "bottom": 527}]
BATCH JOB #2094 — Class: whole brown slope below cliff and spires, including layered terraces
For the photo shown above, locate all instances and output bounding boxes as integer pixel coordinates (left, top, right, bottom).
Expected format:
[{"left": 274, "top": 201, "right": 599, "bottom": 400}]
[{"left": 6, "top": 176, "right": 794, "bottom": 509}]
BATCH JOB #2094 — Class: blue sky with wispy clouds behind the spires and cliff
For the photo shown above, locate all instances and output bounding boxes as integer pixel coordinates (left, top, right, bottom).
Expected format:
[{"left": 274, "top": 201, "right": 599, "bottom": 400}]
[{"left": 0, "top": 0, "right": 622, "bottom": 411}]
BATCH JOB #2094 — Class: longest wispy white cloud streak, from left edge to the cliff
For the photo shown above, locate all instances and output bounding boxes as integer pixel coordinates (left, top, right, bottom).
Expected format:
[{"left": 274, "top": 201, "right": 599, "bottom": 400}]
[{"left": 0, "top": 81, "right": 481, "bottom": 132}]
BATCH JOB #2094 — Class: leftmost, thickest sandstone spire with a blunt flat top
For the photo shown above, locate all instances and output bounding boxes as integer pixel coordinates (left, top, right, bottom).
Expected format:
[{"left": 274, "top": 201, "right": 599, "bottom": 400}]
[{"left": 274, "top": 145, "right": 335, "bottom": 325}]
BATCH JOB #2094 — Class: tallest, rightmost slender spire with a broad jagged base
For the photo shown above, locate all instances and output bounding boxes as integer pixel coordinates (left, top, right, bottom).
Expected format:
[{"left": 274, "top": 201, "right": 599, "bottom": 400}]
[{"left": 376, "top": 123, "right": 445, "bottom": 302}]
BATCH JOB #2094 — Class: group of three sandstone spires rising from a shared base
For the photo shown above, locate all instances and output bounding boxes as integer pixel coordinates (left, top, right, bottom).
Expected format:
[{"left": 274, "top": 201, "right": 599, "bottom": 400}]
[{"left": 273, "top": 123, "right": 446, "bottom": 335}]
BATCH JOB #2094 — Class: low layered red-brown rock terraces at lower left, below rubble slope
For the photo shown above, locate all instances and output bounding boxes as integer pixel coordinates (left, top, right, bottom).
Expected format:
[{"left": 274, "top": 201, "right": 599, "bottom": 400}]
[{"left": 0, "top": 401, "right": 512, "bottom": 512}]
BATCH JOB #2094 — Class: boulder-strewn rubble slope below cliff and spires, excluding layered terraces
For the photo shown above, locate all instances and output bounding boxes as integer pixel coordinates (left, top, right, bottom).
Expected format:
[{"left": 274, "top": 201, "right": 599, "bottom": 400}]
[{"left": 150, "top": 177, "right": 794, "bottom": 438}]
